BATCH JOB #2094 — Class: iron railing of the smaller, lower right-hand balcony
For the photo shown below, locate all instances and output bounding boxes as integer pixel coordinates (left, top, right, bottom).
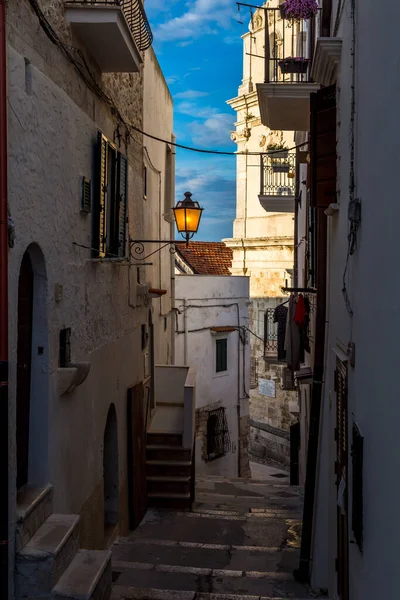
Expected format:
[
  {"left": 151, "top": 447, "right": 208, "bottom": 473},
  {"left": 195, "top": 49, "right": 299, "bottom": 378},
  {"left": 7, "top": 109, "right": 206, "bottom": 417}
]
[{"left": 260, "top": 151, "right": 296, "bottom": 197}]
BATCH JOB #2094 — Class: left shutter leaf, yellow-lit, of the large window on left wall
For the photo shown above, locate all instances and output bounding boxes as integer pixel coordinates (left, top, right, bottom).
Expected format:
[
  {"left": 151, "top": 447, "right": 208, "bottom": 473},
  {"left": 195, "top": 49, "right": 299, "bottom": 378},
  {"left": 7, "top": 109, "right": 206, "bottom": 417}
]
[{"left": 92, "top": 131, "right": 108, "bottom": 258}]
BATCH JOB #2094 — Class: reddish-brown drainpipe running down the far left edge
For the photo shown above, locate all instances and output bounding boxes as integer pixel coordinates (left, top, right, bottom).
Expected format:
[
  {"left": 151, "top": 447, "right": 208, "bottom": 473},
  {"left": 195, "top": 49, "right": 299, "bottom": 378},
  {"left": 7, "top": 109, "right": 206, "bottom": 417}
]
[{"left": 0, "top": 0, "right": 9, "bottom": 600}]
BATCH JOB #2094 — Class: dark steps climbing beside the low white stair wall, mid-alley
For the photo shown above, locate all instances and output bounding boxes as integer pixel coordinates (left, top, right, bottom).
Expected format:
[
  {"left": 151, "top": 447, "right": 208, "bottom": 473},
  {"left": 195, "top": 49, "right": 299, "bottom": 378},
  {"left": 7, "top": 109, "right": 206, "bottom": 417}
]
[{"left": 146, "top": 431, "right": 192, "bottom": 509}]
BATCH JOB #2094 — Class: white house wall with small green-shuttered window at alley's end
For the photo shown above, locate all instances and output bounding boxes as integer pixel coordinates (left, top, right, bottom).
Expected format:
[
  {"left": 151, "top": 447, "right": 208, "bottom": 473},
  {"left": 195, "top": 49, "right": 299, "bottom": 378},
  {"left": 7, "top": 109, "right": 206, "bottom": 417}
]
[{"left": 176, "top": 275, "right": 249, "bottom": 477}]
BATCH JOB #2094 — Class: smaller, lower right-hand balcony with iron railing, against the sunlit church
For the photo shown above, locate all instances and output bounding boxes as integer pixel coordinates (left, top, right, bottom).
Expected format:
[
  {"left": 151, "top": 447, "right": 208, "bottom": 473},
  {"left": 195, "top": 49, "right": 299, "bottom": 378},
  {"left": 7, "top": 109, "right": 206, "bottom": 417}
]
[{"left": 258, "top": 152, "right": 296, "bottom": 213}]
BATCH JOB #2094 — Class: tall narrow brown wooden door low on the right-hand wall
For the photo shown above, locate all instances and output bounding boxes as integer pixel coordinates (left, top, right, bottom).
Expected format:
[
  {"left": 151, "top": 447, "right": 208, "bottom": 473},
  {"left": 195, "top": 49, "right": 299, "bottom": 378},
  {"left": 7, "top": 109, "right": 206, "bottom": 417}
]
[{"left": 335, "top": 359, "right": 349, "bottom": 600}]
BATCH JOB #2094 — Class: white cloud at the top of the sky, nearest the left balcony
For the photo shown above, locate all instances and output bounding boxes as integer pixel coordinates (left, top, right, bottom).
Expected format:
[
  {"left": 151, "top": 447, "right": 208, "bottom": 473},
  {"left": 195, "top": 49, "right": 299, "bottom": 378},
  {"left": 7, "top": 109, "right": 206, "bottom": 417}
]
[{"left": 155, "top": 0, "right": 234, "bottom": 41}]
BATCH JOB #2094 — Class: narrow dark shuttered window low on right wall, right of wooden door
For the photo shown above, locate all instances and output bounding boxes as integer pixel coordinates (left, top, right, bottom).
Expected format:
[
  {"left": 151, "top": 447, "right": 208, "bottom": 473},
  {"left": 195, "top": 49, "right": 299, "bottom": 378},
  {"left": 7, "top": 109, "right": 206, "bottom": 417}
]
[{"left": 351, "top": 423, "right": 364, "bottom": 552}]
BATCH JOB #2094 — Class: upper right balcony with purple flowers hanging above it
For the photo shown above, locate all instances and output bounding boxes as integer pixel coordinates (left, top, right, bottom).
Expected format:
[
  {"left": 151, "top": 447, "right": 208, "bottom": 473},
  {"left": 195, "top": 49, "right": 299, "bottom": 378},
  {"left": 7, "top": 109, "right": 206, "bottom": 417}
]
[{"left": 257, "top": 8, "right": 320, "bottom": 131}]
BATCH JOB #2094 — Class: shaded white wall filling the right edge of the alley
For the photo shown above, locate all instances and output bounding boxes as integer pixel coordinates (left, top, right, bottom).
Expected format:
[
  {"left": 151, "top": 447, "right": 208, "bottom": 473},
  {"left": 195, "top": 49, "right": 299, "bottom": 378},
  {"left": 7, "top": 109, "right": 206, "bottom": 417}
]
[{"left": 296, "top": 0, "right": 400, "bottom": 600}]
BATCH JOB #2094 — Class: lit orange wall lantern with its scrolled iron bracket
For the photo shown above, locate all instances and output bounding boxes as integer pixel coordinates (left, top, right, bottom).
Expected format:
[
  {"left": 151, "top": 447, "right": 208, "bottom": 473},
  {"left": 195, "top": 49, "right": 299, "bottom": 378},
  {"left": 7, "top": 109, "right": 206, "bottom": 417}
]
[{"left": 129, "top": 192, "right": 204, "bottom": 260}]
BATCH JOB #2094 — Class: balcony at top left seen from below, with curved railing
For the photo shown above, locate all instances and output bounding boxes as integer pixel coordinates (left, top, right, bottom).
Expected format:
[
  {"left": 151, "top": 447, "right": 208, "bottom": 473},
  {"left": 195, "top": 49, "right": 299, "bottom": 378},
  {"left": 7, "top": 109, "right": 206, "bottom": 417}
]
[{"left": 65, "top": 0, "right": 153, "bottom": 73}]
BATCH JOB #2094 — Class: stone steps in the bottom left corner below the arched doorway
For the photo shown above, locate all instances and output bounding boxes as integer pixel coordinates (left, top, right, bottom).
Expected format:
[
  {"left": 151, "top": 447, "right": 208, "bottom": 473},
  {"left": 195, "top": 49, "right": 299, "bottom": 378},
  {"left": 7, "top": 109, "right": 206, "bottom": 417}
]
[{"left": 15, "top": 485, "right": 111, "bottom": 600}]
